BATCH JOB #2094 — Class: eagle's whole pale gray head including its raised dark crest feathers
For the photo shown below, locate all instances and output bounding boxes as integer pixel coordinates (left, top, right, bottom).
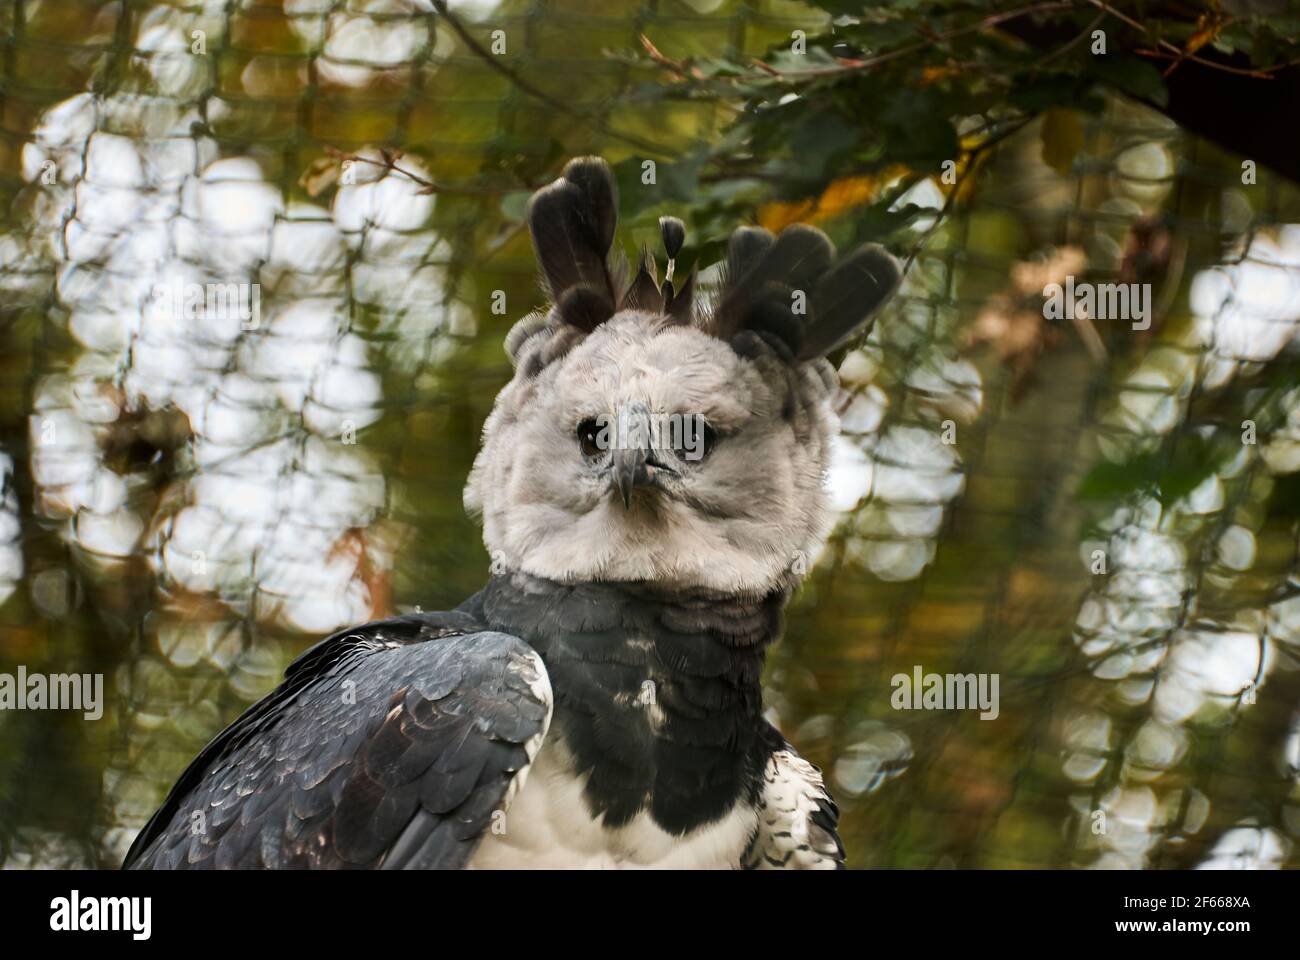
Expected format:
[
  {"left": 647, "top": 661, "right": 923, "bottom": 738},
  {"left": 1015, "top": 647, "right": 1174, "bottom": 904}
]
[{"left": 465, "top": 159, "right": 898, "bottom": 596}]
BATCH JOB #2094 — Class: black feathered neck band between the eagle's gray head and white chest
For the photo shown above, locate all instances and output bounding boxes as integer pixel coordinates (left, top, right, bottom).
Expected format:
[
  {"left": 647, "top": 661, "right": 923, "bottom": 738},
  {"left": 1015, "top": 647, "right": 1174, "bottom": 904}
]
[{"left": 467, "top": 572, "right": 788, "bottom": 834}]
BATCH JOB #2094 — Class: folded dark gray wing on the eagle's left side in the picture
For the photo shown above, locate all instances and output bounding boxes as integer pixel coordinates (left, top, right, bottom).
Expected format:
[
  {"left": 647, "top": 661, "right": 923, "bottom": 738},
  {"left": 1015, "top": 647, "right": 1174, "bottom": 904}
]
[{"left": 124, "top": 613, "right": 551, "bottom": 869}]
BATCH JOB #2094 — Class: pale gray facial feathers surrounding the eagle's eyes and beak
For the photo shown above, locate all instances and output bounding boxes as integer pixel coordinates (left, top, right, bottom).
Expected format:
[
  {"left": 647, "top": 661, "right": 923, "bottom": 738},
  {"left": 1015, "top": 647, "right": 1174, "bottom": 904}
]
[{"left": 465, "top": 312, "right": 833, "bottom": 594}]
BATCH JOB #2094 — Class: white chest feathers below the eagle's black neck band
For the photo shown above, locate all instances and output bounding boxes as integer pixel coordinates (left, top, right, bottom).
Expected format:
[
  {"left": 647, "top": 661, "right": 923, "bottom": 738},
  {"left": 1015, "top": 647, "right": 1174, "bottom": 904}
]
[{"left": 468, "top": 739, "right": 758, "bottom": 869}]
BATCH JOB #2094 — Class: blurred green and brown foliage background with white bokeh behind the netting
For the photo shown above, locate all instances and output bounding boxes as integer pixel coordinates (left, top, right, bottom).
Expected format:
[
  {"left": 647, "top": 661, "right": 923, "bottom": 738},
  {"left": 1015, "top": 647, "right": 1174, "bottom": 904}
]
[{"left": 0, "top": 0, "right": 1300, "bottom": 868}]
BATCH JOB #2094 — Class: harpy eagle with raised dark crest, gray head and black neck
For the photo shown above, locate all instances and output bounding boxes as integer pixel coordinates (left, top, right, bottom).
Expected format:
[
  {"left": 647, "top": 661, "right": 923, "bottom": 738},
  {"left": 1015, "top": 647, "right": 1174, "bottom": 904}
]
[{"left": 125, "top": 157, "right": 900, "bottom": 869}]
